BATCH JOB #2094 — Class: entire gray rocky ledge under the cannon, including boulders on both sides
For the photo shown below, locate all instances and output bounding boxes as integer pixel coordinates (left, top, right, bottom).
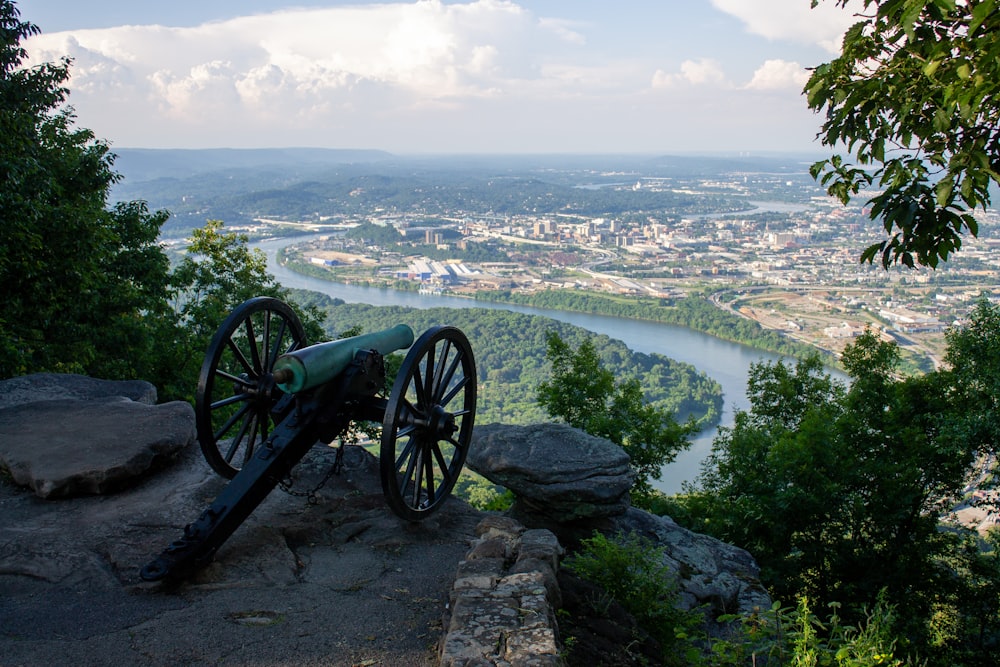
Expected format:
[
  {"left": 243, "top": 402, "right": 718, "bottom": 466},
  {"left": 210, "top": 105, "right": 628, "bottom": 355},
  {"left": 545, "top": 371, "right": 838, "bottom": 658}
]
[{"left": 0, "top": 375, "right": 770, "bottom": 667}]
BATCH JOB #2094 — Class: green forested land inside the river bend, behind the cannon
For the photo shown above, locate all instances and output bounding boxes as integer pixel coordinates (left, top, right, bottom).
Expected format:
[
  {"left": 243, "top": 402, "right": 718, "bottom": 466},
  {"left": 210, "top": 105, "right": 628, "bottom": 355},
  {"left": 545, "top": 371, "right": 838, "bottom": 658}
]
[{"left": 296, "top": 292, "right": 722, "bottom": 425}]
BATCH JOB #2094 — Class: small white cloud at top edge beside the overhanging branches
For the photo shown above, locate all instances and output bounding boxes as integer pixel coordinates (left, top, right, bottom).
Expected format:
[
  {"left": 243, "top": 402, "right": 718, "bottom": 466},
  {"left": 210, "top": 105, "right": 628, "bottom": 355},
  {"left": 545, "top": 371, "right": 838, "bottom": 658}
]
[{"left": 712, "top": 0, "right": 863, "bottom": 53}]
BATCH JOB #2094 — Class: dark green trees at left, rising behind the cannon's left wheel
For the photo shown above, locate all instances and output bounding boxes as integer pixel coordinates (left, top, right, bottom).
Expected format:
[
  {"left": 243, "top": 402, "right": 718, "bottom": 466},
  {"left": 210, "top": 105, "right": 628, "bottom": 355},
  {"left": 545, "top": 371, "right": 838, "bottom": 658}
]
[{"left": 0, "top": 0, "right": 322, "bottom": 399}]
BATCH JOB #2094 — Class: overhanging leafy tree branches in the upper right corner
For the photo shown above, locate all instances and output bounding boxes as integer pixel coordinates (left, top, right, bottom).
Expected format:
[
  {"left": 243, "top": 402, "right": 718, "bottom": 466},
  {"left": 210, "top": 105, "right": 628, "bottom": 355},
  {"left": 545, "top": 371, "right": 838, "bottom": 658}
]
[{"left": 804, "top": 0, "right": 1000, "bottom": 268}]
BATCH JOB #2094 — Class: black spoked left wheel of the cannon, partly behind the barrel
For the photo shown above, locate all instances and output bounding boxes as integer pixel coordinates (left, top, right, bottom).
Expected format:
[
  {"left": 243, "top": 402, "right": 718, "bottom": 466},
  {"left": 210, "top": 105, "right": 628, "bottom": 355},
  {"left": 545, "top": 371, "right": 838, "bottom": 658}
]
[{"left": 194, "top": 296, "right": 306, "bottom": 479}]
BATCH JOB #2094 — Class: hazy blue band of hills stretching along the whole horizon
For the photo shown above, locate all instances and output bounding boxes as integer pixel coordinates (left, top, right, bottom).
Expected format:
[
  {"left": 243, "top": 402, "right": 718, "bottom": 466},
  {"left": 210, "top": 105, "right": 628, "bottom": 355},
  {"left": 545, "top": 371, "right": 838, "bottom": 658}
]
[{"left": 112, "top": 148, "right": 824, "bottom": 237}]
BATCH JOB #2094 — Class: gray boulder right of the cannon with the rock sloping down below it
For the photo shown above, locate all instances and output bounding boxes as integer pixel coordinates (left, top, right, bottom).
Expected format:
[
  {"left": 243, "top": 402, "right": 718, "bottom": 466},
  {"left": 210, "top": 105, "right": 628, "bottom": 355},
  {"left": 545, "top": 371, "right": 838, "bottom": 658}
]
[{"left": 468, "top": 424, "right": 771, "bottom": 615}]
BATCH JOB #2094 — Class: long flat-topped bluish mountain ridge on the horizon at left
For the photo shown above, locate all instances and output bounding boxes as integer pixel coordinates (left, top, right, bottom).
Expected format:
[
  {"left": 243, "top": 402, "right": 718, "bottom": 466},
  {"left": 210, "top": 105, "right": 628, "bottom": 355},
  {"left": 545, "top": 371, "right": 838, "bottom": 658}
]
[{"left": 112, "top": 148, "right": 395, "bottom": 181}]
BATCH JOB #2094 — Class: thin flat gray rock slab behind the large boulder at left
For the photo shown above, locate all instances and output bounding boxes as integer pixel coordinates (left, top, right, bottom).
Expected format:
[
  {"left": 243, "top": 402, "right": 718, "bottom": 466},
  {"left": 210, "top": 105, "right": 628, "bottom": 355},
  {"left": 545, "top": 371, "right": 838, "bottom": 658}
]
[{"left": 0, "top": 373, "right": 156, "bottom": 409}]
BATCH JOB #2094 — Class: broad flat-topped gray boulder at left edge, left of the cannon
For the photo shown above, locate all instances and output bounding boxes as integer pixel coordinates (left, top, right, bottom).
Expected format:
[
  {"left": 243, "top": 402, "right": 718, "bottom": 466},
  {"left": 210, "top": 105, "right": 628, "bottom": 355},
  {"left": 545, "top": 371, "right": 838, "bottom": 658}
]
[{"left": 0, "top": 374, "right": 195, "bottom": 498}]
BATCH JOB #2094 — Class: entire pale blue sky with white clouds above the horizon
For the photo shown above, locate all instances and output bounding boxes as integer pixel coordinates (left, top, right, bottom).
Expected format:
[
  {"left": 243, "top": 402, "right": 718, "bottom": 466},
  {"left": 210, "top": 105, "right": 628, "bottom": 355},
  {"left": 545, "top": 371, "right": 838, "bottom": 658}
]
[{"left": 17, "top": 0, "right": 853, "bottom": 153}]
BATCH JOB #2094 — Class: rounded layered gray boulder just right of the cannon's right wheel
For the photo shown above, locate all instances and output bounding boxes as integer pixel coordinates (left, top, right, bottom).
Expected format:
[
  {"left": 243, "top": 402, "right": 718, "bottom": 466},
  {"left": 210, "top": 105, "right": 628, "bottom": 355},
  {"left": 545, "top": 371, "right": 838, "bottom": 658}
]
[{"left": 466, "top": 424, "right": 635, "bottom": 527}]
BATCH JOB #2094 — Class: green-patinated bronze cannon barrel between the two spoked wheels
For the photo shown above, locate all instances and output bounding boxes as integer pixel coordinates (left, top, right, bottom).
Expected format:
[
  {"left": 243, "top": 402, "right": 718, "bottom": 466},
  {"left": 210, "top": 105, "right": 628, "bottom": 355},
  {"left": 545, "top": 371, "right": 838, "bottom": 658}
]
[{"left": 274, "top": 324, "right": 413, "bottom": 394}]
